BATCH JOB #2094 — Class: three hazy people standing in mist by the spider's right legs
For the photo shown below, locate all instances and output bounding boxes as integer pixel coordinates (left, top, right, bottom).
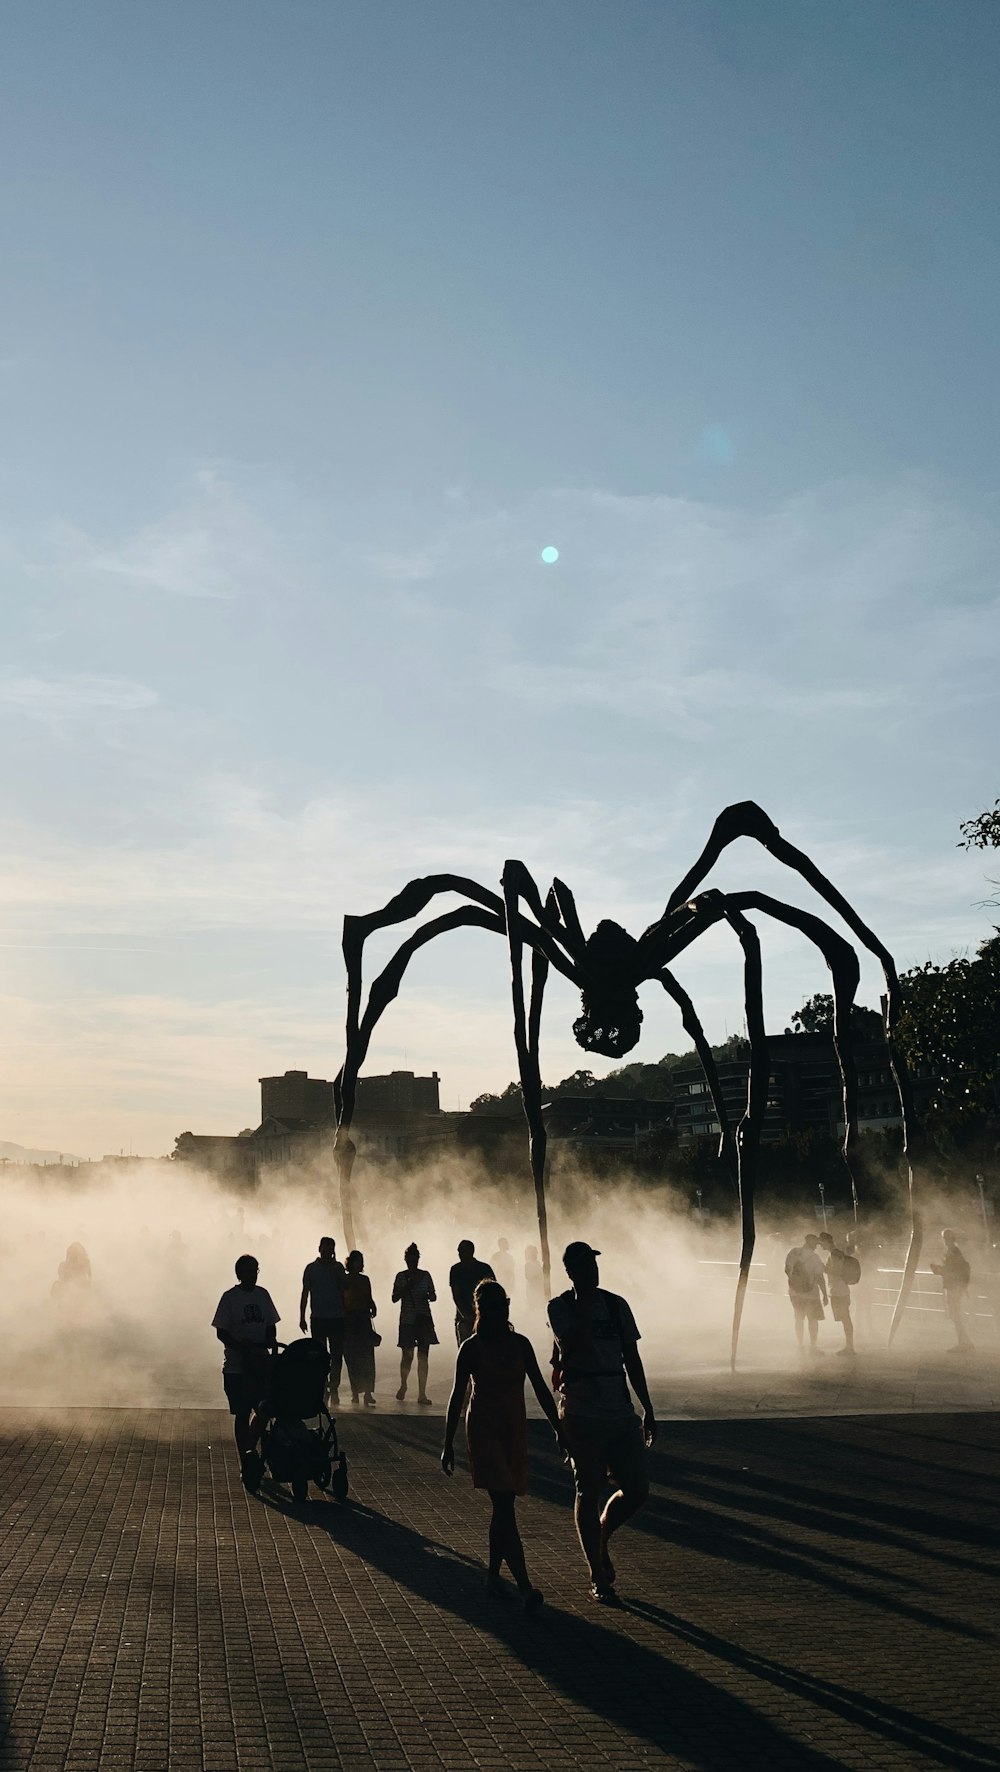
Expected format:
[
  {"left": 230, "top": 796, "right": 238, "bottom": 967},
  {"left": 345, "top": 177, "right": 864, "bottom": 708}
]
[{"left": 785, "top": 1230, "right": 972, "bottom": 1356}]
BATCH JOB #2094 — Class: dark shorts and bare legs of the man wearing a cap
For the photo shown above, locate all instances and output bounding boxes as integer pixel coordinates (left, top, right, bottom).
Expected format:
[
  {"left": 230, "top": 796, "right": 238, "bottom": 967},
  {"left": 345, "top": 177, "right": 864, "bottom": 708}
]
[{"left": 562, "top": 1416, "right": 649, "bottom": 1600}]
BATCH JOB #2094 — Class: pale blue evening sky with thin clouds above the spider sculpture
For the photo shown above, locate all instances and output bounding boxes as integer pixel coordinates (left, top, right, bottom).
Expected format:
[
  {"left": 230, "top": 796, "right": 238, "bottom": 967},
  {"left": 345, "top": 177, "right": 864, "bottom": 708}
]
[{"left": 0, "top": 0, "right": 1000, "bottom": 1155}]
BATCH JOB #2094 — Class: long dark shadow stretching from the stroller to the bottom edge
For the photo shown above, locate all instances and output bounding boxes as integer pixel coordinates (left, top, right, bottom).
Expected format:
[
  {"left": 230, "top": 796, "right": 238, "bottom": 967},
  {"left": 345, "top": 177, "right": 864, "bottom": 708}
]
[{"left": 261, "top": 1494, "right": 842, "bottom": 1772}]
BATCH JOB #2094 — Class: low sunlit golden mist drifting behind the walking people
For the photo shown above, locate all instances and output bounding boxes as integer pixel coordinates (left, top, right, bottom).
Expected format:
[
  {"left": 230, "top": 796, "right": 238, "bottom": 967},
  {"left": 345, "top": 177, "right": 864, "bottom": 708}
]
[{"left": 0, "top": 1161, "right": 996, "bottom": 1416}]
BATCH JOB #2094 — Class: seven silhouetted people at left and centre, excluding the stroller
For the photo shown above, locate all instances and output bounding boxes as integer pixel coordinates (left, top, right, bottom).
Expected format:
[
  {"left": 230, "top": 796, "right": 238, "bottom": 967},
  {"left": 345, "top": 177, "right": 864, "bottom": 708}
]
[{"left": 213, "top": 1237, "right": 656, "bottom": 1613}]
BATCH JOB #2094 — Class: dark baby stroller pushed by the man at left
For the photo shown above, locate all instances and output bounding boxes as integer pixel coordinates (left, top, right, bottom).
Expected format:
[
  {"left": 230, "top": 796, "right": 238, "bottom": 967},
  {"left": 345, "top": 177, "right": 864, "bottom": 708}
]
[{"left": 243, "top": 1341, "right": 348, "bottom": 1501}]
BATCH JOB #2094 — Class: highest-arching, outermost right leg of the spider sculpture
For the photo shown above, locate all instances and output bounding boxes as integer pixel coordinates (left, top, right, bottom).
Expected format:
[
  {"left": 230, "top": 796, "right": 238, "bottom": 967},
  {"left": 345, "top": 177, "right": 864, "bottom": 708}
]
[{"left": 654, "top": 801, "right": 924, "bottom": 1343}]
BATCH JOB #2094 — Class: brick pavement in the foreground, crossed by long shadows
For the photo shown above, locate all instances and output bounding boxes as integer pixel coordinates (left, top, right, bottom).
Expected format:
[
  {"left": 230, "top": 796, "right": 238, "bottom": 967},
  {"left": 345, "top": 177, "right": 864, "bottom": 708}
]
[{"left": 0, "top": 1409, "right": 1000, "bottom": 1772}]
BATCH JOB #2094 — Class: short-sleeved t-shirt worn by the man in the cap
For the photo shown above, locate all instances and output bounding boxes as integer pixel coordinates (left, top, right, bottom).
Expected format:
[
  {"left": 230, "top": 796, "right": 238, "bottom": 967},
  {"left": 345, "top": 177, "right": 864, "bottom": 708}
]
[{"left": 548, "top": 1290, "right": 638, "bottom": 1421}]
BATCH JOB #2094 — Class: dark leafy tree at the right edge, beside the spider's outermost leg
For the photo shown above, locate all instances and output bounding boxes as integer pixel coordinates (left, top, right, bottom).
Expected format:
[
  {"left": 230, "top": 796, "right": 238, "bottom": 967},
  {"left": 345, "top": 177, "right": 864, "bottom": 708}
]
[{"left": 897, "top": 930, "right": 1000, "bottom": 1136}]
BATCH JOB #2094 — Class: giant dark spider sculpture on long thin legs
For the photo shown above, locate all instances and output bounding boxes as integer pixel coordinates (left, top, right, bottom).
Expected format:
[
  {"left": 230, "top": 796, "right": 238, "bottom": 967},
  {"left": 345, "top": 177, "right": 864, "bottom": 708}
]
[{"left": 333, "top": 801, "right": 922, "bottom": 1366}]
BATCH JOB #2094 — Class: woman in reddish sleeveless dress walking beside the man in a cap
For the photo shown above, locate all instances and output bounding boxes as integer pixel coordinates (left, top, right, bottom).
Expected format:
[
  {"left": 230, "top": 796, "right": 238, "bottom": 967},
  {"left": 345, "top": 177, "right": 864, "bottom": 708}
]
[{"left": 441, "top": 1279, "right": 562, "bottom": 1613}]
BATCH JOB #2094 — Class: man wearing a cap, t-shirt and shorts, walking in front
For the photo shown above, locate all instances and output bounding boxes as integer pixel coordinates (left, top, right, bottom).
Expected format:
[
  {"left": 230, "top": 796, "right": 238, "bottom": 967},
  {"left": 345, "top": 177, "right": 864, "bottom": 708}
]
[{"left": 548, "top": 1242, "right": 656, "bottom": 1605}]
